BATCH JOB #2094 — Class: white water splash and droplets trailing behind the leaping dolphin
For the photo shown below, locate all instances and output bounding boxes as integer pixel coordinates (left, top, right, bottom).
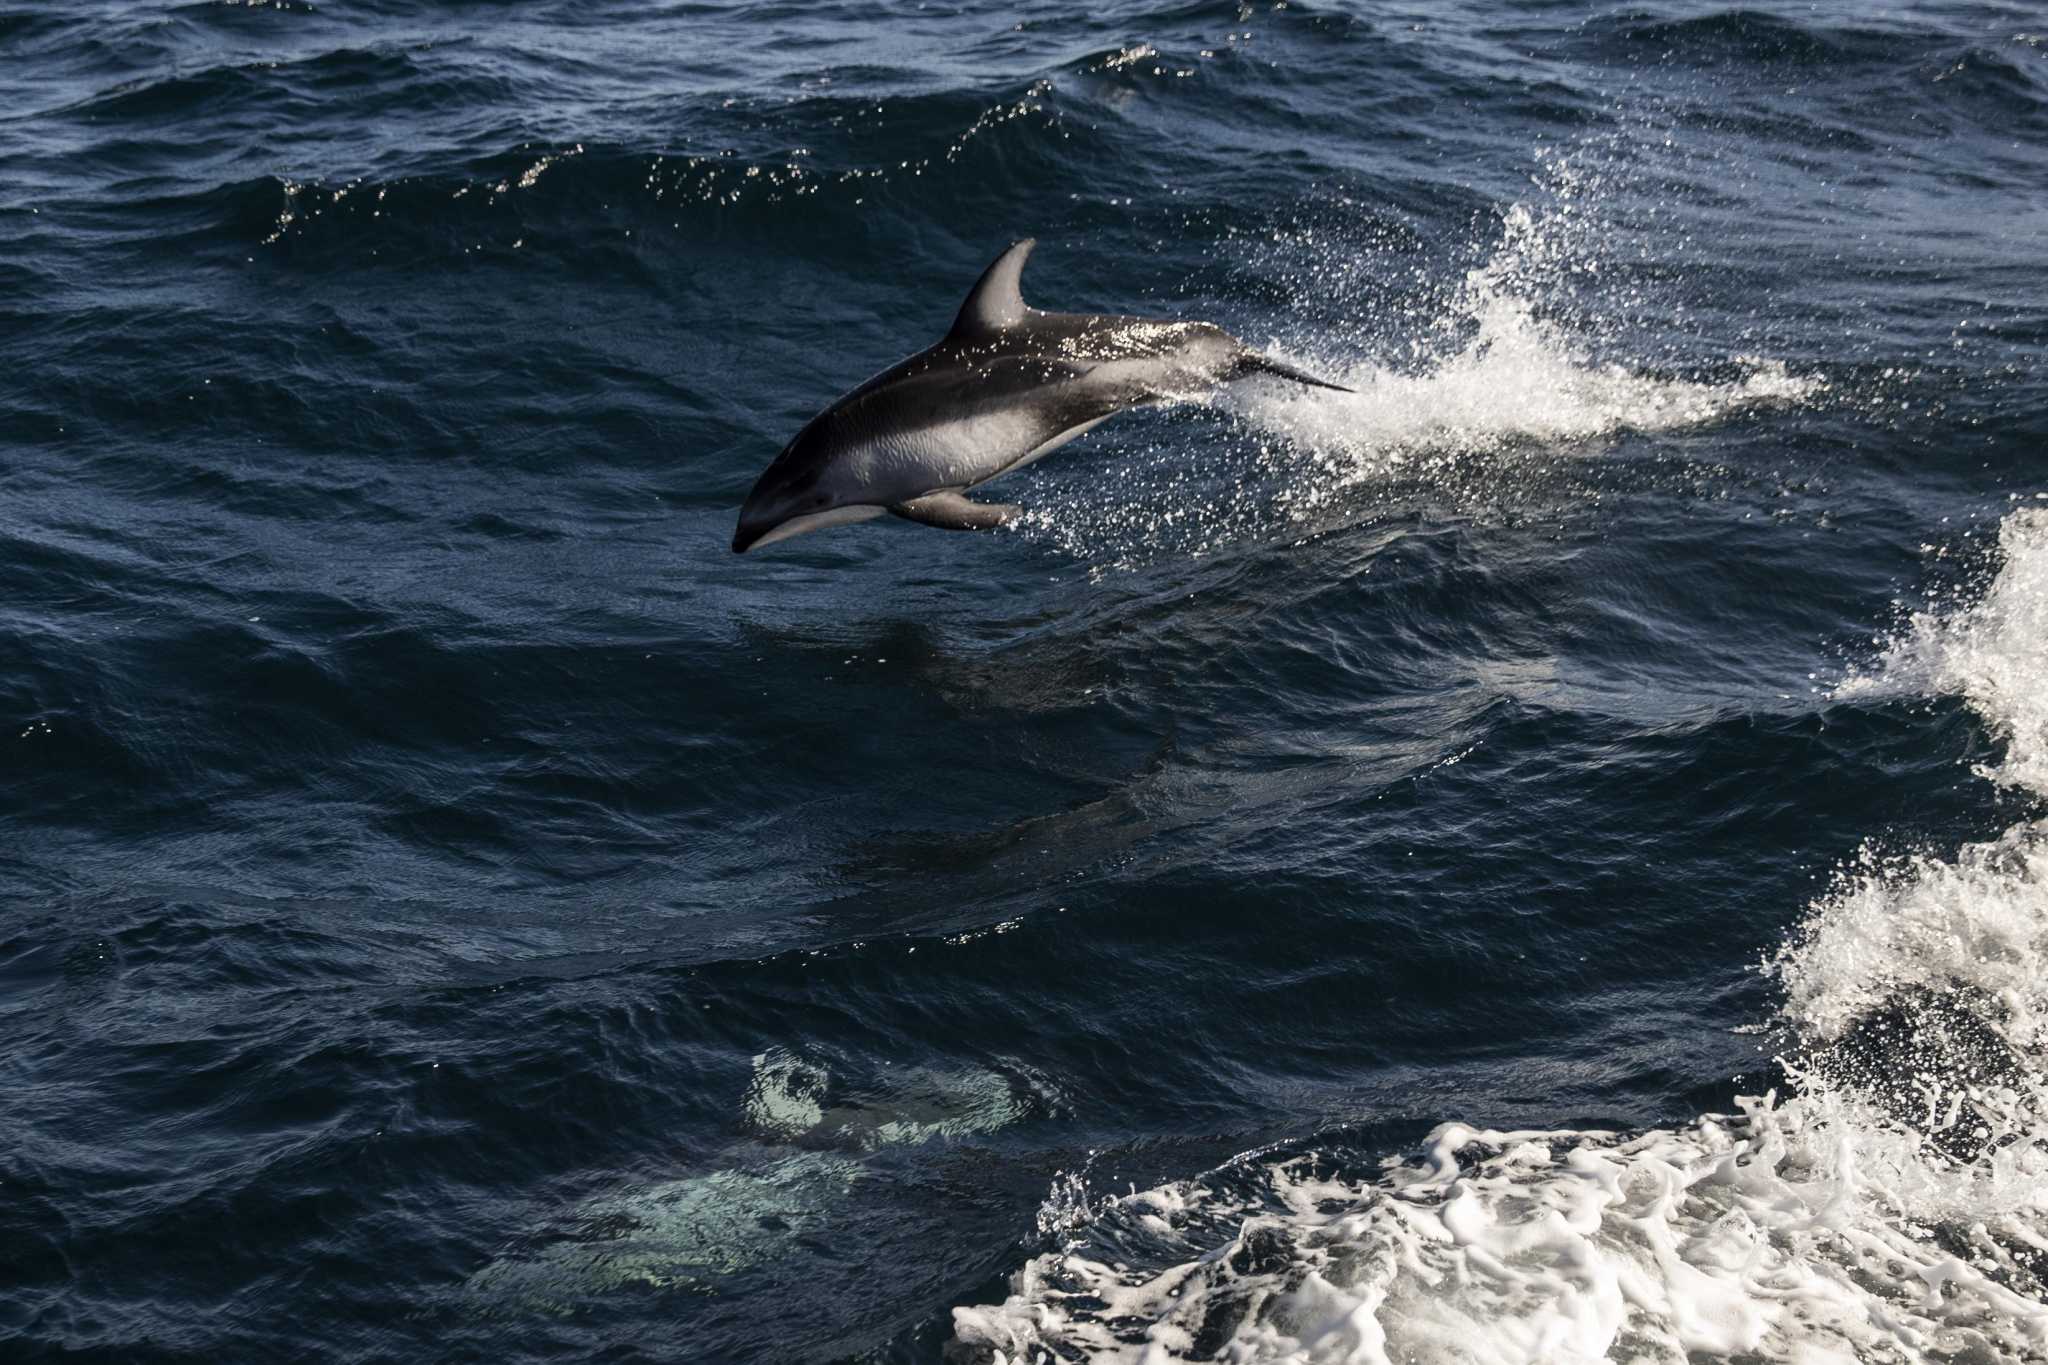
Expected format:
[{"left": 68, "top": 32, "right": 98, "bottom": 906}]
[{"left": 1020, "top": 184, "right": 1827, "bottom": 563}]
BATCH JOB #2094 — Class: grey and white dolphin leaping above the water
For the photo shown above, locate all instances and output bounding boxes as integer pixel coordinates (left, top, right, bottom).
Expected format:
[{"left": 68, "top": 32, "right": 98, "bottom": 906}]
[{"left": 733, "top": 237, "right": 1352, "bottom": 555}]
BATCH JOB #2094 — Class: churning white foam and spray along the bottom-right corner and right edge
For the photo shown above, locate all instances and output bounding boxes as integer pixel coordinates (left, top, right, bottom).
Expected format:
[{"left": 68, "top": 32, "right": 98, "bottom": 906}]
[{"left": 954, "top": 512, "right": 2048, "bottom": 1365}]
